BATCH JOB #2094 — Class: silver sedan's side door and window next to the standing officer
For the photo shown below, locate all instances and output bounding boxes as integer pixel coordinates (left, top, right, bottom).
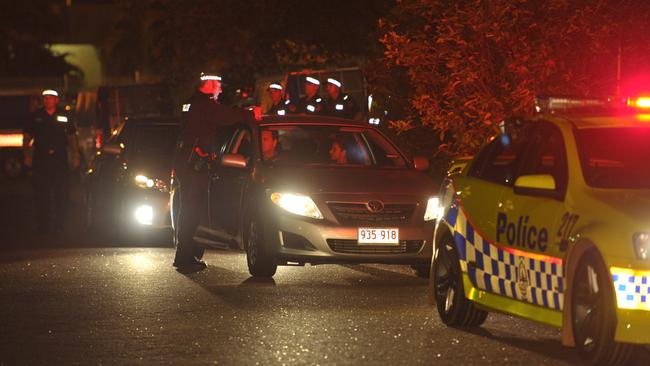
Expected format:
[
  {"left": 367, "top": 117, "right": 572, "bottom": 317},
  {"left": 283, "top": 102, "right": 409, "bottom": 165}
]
[{"left": 210, "top": 127, "right": 253, "bottom": 237}]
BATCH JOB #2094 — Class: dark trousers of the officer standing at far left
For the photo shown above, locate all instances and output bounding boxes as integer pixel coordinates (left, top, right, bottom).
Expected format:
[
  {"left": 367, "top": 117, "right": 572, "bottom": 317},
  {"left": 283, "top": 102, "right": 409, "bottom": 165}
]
[{"left": 32, "top": 166, "right": 68, "bottom": 231}]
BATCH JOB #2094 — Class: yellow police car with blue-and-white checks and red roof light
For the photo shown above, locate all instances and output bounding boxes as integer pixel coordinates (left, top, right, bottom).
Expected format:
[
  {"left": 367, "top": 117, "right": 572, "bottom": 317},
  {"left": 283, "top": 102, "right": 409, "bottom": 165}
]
[{"left": 430, "top": 98, "right": 650, "bottom": 364}]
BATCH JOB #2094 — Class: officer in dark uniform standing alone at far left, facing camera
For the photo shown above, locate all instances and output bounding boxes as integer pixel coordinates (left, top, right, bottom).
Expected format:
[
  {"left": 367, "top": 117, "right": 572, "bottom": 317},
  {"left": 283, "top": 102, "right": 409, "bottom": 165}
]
[{"left": 23, "top": 89, "right": 79, "bottom": 233}]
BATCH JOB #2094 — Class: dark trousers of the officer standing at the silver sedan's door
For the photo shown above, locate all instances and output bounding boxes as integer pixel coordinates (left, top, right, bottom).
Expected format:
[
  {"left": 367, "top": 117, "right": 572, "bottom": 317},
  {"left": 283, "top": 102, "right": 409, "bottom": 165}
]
[{"left": 174, "top": 169, "right": 208, "bottom": 264}]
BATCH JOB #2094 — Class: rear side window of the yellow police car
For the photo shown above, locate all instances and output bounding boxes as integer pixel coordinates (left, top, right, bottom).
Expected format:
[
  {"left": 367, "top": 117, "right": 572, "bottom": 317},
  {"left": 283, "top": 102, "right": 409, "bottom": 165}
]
[{"left": 470, "top": 135, "right": 525, "bottom": 186}]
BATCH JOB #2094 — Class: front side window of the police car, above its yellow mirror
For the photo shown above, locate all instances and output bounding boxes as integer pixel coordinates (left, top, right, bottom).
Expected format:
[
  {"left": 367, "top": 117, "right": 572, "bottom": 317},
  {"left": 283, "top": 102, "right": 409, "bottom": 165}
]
[{"left": 518, "top": 121, "right": 568, "bottom": 192}]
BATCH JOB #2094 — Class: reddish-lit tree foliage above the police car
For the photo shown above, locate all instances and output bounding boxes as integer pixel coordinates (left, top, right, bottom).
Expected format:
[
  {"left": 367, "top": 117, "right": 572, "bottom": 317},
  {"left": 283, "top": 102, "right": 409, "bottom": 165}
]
[{"left": 380, "top": 0, "right": 648, "bottom": 156}]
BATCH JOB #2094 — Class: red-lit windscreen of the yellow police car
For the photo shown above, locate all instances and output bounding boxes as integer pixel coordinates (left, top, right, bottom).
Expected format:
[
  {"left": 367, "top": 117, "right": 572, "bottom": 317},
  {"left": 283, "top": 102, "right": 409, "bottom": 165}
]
[{"left": 576, "top": 127, "right": 650, "bottom": 189}]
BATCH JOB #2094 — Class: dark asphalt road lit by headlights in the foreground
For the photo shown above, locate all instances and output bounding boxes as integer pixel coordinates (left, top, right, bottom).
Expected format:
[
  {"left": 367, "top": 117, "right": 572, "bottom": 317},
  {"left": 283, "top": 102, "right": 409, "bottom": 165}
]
[{"left": 0, "top": 176, "right": 650, "bottom": 365}]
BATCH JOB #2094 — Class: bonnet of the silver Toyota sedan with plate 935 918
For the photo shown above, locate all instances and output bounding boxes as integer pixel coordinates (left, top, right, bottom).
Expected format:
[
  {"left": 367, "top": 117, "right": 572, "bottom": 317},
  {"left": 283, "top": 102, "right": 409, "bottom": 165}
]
[{"left": 263, "top": 166, "right": 439, "bottom": 195}]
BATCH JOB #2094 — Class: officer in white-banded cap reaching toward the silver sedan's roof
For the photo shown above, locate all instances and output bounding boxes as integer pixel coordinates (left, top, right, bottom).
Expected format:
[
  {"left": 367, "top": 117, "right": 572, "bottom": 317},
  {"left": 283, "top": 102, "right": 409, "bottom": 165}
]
[{"left": 173, "top": 73, "right": 252, "bottom": 271}]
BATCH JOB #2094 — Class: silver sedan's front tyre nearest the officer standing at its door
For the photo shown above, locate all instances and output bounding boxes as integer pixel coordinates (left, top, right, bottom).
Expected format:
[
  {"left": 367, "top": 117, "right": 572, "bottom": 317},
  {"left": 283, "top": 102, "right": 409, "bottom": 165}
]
[{"left": 245, "top": 217, "right": 278, "bottom": 277}]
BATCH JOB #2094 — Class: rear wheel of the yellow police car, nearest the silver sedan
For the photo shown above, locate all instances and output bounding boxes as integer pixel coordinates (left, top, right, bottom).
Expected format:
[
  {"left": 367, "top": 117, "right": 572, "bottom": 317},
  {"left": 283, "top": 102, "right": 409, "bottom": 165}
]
[{"left": 432, "top": 238, "right": 488, "bottom": 327}]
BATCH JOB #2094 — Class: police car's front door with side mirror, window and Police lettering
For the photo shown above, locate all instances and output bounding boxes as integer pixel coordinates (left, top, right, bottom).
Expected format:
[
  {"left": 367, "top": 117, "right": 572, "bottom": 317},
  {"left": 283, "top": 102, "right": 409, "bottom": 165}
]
[{"left": 496, "top": 121, "right": 575, "bottom": 310}]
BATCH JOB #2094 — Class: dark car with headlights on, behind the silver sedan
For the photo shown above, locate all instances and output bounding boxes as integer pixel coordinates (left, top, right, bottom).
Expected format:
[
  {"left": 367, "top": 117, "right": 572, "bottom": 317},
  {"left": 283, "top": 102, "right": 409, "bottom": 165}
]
[{"left": 85, "top": 117, "right": 180, "bottom": 237}]
